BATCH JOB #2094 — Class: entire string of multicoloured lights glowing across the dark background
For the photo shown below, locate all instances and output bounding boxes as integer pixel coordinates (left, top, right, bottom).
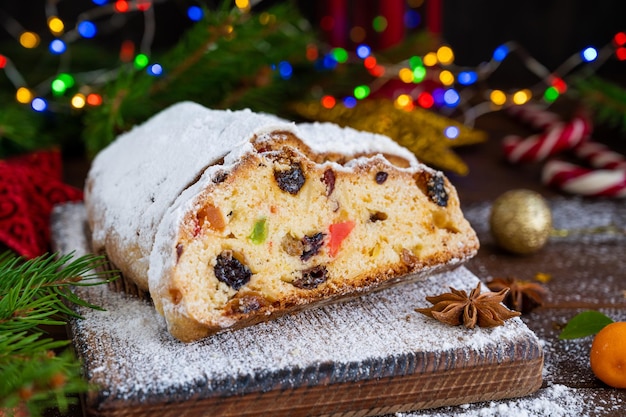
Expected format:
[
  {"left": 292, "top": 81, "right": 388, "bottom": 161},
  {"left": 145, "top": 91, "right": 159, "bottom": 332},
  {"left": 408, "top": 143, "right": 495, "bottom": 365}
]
[{"left": 0, "top": 0, "right": 626, "bottom": 134}]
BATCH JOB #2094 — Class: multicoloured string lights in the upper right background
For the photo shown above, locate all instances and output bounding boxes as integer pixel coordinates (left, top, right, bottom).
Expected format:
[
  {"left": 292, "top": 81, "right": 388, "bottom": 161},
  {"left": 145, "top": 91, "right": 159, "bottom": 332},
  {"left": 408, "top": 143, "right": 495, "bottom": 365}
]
[{"left": 308, "top": 32, "right": 626, "bottom": 125}]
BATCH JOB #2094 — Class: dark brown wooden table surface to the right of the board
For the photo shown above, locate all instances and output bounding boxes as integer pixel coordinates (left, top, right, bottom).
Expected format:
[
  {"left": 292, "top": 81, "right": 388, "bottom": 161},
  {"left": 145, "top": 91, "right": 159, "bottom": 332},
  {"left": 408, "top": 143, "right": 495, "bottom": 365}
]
[{"left": 54, "top": 102, "right": 626, "bottom": 416}]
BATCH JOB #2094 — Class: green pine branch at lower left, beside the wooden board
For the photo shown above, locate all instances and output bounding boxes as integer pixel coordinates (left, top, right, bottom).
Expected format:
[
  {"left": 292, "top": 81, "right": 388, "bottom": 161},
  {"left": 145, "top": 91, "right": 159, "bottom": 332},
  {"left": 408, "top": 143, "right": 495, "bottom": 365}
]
[{"left": 0, "top": 252, "right": 114, "bottom": 416}]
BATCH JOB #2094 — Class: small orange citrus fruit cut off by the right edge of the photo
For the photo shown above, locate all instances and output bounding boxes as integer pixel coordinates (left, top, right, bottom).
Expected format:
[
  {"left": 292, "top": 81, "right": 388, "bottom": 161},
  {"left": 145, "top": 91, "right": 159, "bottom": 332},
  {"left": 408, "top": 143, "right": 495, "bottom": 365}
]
[{"left": 589, "top": 321, "right": 626, "bottom": 388}]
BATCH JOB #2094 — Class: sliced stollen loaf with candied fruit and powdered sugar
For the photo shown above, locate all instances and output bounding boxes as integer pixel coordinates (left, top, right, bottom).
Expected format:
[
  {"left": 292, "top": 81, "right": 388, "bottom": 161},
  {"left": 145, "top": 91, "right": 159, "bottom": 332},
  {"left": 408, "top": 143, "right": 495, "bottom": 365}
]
[{"left": 85, "top": 102, "right": 479, "bottom": 342}]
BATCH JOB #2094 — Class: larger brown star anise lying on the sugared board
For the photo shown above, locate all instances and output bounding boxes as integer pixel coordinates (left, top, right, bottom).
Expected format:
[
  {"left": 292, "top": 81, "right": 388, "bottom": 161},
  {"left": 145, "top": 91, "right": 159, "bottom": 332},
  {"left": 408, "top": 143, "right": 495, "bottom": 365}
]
[{"left": 415, "top": 282, "right": 521, "bottom": 329}]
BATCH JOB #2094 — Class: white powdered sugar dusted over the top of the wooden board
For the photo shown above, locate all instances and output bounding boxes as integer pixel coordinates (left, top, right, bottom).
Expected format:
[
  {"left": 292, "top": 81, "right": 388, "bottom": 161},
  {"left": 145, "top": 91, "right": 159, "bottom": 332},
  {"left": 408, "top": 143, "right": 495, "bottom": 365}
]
[{"left": 53, "top": 204, "right": 538, "bottom": 402}]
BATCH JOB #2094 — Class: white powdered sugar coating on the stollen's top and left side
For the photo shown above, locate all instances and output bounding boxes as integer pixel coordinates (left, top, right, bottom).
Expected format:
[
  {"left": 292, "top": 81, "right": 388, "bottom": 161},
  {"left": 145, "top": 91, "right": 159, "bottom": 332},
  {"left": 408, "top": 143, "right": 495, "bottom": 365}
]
[{"left": 85, "top": 102, "right": 428, "bottom": 289}]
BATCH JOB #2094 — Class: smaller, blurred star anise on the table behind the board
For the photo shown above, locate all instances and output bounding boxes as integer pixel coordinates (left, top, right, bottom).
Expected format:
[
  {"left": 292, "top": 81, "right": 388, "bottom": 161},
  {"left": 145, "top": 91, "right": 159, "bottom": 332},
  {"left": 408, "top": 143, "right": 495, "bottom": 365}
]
[{"left": 487, "top": 278, "right": 547, "bottom": 314}]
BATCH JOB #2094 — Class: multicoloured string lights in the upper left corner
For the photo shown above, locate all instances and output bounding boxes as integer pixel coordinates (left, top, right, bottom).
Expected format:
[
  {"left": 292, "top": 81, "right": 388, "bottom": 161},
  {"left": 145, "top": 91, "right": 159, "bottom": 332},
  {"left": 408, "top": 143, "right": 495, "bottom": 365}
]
[{"left": 0, "top": 0, "right": 236, "bottom": 112}]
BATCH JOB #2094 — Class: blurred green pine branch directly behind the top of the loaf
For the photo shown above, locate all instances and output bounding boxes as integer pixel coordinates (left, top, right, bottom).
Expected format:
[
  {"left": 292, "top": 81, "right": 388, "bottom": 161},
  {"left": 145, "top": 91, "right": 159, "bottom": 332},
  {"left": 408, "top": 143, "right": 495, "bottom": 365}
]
[{"left": 83, "top": 2, "right": 316, "bottom": 156}]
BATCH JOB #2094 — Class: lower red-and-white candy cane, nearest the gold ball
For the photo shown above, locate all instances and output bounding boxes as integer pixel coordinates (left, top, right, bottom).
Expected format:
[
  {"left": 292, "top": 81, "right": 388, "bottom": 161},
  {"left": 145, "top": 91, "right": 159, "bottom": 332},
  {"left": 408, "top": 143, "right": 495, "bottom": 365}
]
[{"left": 541, "top": 160, "right": 626, "bottom": 197}]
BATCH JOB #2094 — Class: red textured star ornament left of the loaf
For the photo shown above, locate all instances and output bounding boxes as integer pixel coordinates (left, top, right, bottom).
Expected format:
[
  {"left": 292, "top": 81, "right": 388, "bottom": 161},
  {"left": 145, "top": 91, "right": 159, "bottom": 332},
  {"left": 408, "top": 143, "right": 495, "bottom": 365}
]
[{"left": 0, "top": 150, "right": 83, "bottom": 258}]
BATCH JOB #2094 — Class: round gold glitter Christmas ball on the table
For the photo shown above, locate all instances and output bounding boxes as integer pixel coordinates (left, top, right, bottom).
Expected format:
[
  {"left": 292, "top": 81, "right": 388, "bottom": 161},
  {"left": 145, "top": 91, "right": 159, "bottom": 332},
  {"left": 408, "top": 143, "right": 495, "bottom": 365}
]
[{"left": 489, "top": 189, "right": 552, "bottom": 255}]
